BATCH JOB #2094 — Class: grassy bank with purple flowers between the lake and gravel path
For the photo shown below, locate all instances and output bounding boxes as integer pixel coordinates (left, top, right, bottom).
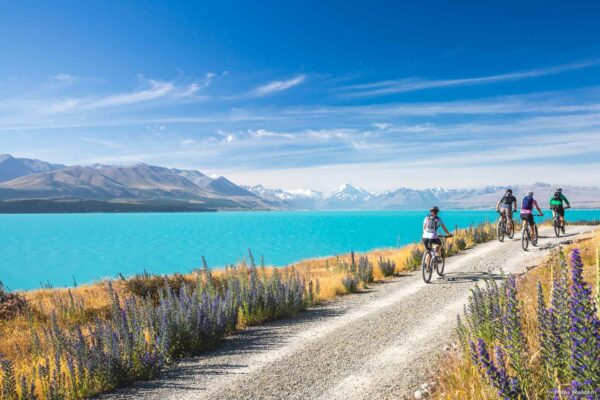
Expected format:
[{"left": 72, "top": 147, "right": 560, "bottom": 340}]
[{"left": 0, "top": 224, "right": 495, "bottom": 400}]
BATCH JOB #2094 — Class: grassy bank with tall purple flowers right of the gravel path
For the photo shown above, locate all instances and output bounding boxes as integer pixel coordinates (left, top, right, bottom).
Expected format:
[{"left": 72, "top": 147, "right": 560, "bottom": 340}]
[{"left": 433, "top": 230, "right": 600, "bottom": 400}]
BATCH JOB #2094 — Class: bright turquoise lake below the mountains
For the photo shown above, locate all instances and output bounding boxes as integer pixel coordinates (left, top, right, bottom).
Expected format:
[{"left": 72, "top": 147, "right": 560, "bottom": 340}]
[{"left": 0, "top": 210, "right": 600, "bottom": 290}]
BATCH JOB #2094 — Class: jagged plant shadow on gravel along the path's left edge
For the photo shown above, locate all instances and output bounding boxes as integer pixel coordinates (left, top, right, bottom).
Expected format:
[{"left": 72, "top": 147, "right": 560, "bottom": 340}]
[{"left": 97, "top": 306, "right": 347, "bottom": 399}]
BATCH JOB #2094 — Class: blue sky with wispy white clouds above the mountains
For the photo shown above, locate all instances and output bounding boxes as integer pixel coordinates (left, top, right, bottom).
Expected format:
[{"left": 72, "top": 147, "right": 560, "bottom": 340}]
[{"left": 0, "top": 1, "right": 600, "bottom": 190}]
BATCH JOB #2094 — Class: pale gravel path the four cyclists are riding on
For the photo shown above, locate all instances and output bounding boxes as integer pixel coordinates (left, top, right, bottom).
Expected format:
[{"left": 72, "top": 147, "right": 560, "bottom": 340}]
[{"left": 102, "top": 226, "right": 593, "bottom": 400}]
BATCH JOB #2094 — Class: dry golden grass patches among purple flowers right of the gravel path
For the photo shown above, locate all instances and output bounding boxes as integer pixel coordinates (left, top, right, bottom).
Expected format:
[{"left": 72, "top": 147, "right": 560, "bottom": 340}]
[{"left": 433, "top": 230, "right": 600, "bottom": 400}]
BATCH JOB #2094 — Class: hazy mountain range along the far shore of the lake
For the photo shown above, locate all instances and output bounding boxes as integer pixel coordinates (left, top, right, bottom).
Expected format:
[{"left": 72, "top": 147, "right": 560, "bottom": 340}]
[{"left": 0, "top": 155, "right": 600, "bottom": 212}]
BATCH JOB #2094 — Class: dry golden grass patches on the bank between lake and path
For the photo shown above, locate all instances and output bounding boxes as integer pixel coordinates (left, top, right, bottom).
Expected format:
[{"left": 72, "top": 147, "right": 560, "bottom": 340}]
[{"left": 0, "top": 225, "right": 494, "bottom": 390}]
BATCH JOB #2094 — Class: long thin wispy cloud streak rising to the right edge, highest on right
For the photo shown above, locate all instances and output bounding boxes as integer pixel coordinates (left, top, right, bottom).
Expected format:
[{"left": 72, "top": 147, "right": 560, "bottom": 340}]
[{"left": 338, "top": 60, "right": 600, "bottom": 97}]
